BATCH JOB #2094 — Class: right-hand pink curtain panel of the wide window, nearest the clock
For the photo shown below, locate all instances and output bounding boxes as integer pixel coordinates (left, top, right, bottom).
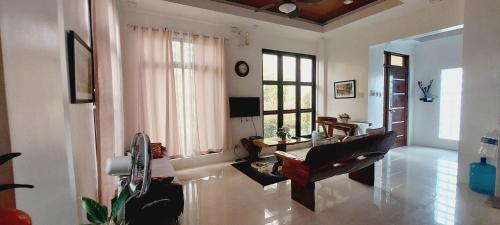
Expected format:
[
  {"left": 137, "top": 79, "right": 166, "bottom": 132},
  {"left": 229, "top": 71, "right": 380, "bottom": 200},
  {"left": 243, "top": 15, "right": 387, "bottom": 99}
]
[{"left": 194, "top": 36, "right": 230, "bottom": 153}]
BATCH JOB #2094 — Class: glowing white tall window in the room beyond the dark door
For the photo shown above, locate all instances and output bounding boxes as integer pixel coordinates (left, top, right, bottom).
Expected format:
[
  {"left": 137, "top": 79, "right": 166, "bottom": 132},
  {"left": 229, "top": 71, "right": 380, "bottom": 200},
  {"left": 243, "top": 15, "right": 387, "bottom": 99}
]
[{"left": 439, "top": 68, "right": 462, "bottom": 141}]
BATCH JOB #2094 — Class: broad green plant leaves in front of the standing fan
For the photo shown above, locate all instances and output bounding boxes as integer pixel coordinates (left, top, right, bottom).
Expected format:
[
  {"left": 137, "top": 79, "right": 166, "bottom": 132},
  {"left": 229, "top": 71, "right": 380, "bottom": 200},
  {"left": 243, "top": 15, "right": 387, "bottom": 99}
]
[{"left": 82, "top": 188, "right": 135, "bottom": 225}]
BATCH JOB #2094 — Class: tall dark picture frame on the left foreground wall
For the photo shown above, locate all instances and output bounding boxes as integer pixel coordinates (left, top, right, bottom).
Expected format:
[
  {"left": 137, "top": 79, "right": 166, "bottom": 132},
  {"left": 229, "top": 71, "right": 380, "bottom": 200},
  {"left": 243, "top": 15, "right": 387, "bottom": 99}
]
[{"left": 66, "top": 30, "right": 95, "bottom": 104}]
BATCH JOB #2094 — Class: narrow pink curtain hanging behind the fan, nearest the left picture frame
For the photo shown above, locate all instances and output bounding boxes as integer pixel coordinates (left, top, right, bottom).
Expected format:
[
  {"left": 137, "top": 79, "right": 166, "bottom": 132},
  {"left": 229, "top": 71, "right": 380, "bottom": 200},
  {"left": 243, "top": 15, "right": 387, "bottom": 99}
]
[{"left": 93, "top": 0, "right": 125, "bottom": 205}]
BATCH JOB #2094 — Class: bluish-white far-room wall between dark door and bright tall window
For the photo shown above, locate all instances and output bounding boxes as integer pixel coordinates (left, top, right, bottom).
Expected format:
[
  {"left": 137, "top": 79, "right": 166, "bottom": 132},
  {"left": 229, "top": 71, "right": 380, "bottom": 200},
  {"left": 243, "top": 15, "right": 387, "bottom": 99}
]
[{"left": 410, "top": 35, "right": 463, "bottom": 150}]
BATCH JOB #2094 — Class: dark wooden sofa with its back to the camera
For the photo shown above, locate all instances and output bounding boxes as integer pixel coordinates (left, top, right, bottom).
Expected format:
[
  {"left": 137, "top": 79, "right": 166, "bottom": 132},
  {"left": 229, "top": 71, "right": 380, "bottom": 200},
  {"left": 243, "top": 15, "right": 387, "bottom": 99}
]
[{"left": 274, "top": 131, "right": 396, "bottom": 211}]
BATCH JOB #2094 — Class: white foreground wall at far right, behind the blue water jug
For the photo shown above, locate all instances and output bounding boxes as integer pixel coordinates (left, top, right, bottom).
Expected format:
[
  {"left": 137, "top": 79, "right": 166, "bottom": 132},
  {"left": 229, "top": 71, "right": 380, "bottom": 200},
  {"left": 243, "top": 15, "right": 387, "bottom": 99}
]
[{"left": 458, "top": 0, "right": 500, "bottom": 185}]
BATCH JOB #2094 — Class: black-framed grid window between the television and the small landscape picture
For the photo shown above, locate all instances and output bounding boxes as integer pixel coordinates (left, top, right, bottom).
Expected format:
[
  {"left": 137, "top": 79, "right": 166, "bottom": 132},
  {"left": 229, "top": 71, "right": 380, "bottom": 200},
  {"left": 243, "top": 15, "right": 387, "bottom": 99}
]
[{"left": 262, "top": 49, "right": 316, "bottom": 137}]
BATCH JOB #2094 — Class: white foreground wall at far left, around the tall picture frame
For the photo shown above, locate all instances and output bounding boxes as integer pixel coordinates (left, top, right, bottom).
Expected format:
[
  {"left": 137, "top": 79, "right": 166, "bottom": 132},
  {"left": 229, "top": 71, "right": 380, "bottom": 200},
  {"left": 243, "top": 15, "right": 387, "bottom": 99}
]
[{"left": 0, "top": 0, "right": 97, "bottom": 222}]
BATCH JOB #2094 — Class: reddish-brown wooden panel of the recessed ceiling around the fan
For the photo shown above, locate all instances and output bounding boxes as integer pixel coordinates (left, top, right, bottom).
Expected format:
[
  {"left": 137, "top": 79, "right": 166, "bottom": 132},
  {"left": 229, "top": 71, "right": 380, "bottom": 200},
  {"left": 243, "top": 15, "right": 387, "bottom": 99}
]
[{"left": 225, "top": 0, "right": 377, "bottom": 24}]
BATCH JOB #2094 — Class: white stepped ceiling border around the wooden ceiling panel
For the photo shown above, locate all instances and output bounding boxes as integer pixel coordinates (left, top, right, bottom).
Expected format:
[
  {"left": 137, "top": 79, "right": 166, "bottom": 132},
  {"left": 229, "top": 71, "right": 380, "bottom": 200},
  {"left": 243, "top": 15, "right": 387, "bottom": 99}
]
[{"left": 127, "top": 0, "right": 408, "bottom": 32}]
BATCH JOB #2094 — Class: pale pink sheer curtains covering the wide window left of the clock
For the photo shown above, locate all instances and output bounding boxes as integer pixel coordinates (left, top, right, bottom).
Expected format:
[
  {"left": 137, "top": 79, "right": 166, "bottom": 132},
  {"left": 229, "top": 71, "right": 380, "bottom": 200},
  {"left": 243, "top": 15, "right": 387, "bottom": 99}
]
[{"left": 136, "top": 28, "right": 229, "bottom": 157}]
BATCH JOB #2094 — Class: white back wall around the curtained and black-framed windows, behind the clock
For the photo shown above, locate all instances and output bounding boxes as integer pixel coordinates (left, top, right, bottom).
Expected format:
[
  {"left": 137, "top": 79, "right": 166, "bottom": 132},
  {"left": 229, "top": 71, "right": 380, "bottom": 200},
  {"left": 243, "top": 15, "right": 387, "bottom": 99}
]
[{"left": 120, "top": 7, "right": 320, "bottom": 169}]
